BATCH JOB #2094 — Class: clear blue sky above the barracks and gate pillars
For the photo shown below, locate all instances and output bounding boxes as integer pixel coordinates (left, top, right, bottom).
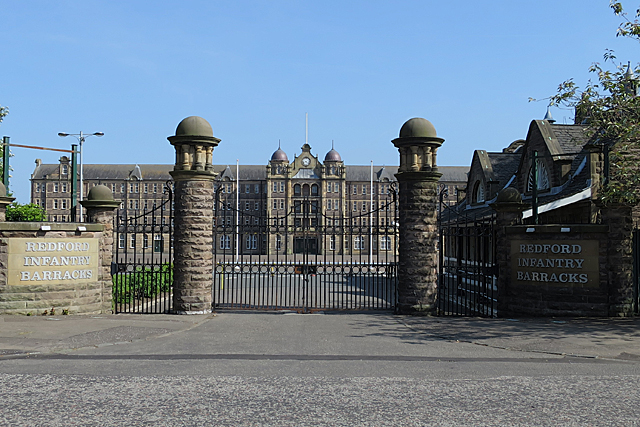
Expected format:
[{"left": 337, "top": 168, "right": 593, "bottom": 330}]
[{"left": 0, "top": 0, "right": 639, "bottom": 203}]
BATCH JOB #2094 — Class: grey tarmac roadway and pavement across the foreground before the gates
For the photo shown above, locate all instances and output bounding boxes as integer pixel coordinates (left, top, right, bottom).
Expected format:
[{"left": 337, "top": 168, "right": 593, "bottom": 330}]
[{"left": 0, "top": 312, "right": 640, "bottom": 426}]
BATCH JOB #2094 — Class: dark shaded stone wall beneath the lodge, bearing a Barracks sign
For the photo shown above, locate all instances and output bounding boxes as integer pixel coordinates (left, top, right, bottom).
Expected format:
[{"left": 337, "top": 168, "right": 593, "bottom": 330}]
[{"left": 497, "top": 225, "right": 608, "bottom": 317}]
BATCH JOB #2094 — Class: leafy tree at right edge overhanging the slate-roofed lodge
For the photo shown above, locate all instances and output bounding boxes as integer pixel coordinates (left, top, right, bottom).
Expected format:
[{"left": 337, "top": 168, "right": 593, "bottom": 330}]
[{"left": 549, "top": 1, "right": 640, "bottom": 205}]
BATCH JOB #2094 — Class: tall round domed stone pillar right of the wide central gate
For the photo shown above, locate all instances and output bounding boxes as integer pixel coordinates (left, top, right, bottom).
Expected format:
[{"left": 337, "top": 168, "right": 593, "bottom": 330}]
[{"left": 392, "top": 118, "right": 444, "bottom": 314}]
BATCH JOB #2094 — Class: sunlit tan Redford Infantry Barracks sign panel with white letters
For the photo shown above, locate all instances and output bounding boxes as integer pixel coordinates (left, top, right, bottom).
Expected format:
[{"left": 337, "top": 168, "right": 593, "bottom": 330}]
[{"left": 7, "top": 238, "right": 98, "bottom": 285}]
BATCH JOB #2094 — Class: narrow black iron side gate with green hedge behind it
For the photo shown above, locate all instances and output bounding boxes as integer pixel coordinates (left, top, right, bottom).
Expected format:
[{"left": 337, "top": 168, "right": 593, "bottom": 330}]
[{"left": 111, "top": 181, "right": 173, "bottom": 313}]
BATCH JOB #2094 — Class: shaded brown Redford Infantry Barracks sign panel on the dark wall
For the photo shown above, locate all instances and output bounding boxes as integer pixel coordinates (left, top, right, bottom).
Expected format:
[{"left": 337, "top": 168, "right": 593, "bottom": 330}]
[{"left": 511, "top": 240, "right": 599, "bottom": 287}]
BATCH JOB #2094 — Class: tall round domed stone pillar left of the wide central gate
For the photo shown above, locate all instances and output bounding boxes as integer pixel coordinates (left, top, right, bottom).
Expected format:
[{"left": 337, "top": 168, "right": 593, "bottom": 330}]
[{"left": 168, "top": 116, "right": 220, "bottom": 314}]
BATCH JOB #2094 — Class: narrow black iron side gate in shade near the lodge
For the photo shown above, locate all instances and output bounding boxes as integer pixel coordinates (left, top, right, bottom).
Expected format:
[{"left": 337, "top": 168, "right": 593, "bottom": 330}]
[{"left": 437, "top": 196, "right": 498, "bottom": 317}]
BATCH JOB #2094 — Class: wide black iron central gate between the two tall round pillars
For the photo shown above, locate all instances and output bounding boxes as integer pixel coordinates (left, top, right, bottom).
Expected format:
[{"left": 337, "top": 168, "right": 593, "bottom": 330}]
[{"left": 212, "top": 191, "right": 398, "bottom": 312}]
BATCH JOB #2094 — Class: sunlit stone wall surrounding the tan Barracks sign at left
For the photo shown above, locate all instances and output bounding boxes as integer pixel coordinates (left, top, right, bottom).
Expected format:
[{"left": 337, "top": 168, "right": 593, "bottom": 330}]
[{"left": 0, "top": 222, "right": 113, "bottom": 315}]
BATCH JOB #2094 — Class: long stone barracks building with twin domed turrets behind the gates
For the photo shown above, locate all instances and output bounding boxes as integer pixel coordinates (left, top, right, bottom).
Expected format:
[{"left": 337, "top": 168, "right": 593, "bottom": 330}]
[{"left": 31, "top": 144, "right": 469, "bottom": 254}]
